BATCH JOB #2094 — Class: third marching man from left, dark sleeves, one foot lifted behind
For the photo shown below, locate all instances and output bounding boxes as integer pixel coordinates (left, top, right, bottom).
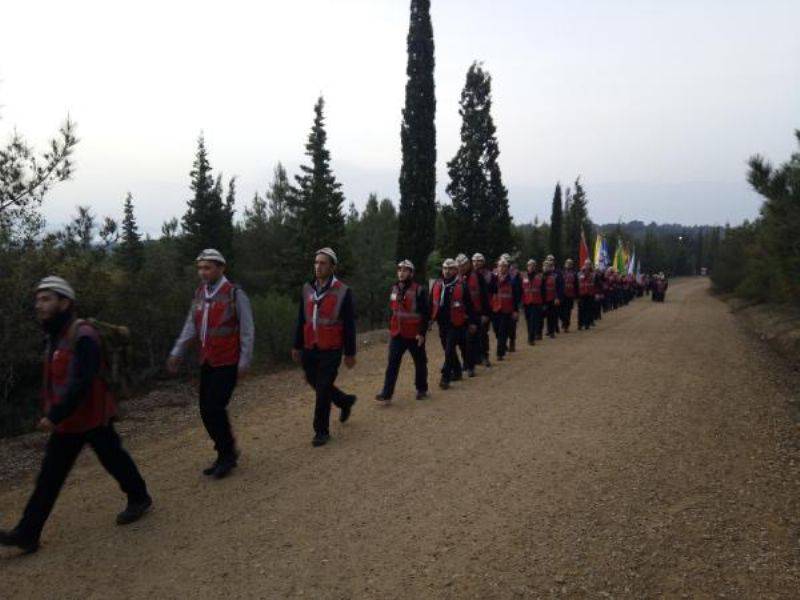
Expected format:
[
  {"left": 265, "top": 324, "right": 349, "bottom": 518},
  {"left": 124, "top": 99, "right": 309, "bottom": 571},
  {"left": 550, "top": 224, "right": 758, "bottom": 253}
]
[{"left": 292, "top": 247, "right": 356, "bottom": 448}]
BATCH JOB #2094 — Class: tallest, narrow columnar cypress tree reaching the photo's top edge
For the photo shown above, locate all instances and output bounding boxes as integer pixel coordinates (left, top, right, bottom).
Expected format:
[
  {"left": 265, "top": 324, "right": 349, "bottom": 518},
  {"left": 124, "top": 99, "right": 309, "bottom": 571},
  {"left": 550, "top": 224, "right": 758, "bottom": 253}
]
[{"left": 395, "top": 0, "right": 436, "bottom": 281}]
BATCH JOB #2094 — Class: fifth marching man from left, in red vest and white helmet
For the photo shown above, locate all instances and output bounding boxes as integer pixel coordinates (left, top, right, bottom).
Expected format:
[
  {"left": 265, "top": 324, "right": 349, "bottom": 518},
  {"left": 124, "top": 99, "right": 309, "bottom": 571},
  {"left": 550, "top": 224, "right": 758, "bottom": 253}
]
[{"left": 431, "top": 258, "right": 478, "bottom": 390}]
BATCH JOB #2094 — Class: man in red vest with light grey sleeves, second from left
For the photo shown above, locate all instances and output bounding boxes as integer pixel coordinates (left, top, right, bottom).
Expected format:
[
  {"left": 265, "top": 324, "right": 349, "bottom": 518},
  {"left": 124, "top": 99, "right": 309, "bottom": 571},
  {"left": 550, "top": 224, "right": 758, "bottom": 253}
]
[{"left": 167, "top": 248, "right": 255, "bottom": 479}]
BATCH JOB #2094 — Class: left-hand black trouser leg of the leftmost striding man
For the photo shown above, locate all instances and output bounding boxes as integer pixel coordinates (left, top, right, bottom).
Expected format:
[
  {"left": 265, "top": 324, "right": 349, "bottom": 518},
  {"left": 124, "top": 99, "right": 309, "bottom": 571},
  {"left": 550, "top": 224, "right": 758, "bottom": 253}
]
[{"left": 17, "top": 433, "right": 85, "bottom": 540}]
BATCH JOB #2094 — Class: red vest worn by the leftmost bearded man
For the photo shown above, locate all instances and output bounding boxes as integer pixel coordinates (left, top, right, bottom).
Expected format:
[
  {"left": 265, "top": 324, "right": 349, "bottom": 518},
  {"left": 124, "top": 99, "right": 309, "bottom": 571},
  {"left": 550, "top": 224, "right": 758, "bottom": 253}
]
[{"left": 43, "top": 321, "right": 117, "bottom": 433}]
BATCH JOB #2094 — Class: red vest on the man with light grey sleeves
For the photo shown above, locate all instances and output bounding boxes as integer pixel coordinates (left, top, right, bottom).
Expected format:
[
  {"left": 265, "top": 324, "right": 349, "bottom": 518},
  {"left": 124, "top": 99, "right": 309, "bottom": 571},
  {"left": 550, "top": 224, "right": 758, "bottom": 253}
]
[{"left": 194, "top": 281, "right": 240, "bottom": 367}]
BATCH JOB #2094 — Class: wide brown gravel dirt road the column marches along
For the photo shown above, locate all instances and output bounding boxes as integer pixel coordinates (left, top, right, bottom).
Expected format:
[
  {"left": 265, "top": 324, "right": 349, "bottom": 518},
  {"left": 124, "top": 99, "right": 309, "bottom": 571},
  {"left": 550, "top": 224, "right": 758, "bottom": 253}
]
[{"left": 0, "top": 279, "right": 800, "bottom": 600}]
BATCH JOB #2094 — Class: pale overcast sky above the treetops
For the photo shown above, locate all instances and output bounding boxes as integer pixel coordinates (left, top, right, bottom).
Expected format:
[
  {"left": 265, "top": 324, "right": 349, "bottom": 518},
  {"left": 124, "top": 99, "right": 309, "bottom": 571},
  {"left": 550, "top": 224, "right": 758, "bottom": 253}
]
[{"left": 0, "top": 0, "right": 800, "bottom": 233}]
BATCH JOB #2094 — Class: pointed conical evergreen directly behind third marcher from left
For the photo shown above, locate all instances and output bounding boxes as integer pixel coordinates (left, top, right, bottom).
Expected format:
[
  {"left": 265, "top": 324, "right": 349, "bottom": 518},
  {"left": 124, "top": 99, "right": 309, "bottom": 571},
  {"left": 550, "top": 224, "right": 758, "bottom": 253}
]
[{"left": 292, "top": 96, "right": 349, "bottom": 273}]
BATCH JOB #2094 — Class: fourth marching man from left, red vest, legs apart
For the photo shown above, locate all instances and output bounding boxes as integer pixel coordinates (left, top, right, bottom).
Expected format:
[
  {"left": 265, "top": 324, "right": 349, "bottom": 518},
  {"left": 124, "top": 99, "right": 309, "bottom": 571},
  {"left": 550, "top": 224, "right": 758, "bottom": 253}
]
[{"left": 375, "top": 260, "right": 429, "bottom": 402}]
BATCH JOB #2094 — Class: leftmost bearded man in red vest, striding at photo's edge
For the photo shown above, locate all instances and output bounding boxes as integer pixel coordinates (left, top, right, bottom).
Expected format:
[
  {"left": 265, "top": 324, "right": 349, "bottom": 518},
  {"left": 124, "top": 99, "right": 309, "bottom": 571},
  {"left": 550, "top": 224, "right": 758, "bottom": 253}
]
[{"left": 0, "top": 276, "right": 153, "bottom": 554}]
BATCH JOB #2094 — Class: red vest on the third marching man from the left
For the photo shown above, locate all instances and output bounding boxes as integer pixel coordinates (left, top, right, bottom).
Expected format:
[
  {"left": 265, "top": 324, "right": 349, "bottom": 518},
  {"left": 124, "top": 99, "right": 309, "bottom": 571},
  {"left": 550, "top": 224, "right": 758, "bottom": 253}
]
[{"left": 303, "top": 279, "right": 347, "bottom": 350}]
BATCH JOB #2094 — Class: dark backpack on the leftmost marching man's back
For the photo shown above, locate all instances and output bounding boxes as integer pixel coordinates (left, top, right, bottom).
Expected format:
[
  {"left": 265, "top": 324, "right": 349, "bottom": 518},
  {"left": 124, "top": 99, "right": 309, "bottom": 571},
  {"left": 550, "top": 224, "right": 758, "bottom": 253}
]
[{"left": 69, "top": 319, "right": 133, "bottom": 398}]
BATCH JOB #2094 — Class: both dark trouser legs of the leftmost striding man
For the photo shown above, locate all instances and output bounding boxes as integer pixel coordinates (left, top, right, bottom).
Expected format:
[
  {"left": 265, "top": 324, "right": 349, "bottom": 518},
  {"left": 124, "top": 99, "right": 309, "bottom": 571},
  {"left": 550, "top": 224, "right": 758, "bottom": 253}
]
[{"left": 17, "top": 425, "right": 147, "bottom": 540}]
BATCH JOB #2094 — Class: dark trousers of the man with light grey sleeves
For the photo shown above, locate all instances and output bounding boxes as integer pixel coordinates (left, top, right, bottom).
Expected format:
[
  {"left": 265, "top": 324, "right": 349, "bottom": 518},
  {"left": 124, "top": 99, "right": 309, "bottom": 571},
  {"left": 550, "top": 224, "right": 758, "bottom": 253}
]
[{"left": 200, "top": 364, "right": 239, "bottom": 456}]
